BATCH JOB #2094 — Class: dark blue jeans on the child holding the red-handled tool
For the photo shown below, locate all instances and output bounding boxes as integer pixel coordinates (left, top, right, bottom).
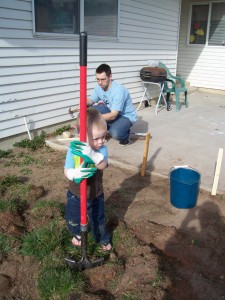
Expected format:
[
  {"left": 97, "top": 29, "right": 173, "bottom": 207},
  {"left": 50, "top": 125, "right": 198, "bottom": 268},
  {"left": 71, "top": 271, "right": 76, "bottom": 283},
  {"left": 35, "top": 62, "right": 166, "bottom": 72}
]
[{"left": 65, "top": 191, "right": 110, "bottom": 244}]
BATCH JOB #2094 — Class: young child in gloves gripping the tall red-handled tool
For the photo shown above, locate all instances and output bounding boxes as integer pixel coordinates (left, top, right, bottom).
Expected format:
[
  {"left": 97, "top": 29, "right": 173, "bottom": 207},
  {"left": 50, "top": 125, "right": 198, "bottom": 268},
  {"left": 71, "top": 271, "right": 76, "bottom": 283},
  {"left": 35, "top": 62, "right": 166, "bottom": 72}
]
[{"left": 64, "top": 108, "right": 112, "bottom": 251}]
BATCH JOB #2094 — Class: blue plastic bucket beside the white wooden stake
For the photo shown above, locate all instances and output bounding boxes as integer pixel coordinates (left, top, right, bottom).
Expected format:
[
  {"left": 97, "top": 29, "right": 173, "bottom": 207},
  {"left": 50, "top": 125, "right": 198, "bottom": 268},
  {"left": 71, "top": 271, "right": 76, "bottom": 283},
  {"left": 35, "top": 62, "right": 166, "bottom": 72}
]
[{"left": 170, "top": 167, "right": 201, "bottom": 208}]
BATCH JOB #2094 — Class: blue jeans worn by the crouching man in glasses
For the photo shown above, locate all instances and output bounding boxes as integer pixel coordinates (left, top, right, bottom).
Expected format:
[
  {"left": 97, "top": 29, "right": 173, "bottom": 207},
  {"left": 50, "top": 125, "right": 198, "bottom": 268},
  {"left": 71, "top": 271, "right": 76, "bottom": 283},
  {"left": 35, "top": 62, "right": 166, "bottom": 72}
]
[{"left": 93, "top": 104, "right": 133, "bottom": 141}]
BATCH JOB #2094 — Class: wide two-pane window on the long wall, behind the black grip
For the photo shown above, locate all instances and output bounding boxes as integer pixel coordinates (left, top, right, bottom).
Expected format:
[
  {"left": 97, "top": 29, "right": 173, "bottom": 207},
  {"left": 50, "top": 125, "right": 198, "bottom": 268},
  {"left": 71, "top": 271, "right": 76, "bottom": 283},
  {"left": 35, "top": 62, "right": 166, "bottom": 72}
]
[{"left": 33, "top": 0, "right": 118, "bottom": 37}]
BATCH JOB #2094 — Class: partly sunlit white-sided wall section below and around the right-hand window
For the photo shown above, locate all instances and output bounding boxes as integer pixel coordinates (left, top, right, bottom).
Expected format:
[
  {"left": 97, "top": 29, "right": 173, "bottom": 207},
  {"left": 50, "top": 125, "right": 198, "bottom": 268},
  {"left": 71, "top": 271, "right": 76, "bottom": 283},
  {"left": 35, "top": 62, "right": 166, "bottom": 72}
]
[{"left": 177, "top": 0, "right": 225, "bottom": 93}]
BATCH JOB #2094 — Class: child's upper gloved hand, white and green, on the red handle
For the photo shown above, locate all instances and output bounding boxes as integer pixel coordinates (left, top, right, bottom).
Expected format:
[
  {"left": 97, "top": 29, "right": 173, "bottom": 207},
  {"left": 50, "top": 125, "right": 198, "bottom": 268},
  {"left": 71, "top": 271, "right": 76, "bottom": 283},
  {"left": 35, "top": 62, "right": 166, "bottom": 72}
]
[{"left": 70, "top": 141, "right": 104, "bottom": 165}]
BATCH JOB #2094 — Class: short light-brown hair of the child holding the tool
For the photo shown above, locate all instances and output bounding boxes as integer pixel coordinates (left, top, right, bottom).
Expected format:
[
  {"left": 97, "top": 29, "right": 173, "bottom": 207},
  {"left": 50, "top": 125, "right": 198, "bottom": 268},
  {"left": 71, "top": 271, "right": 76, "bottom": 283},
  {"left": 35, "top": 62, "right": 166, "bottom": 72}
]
[{"left": 76, "top": 107, "right": 107, "bottom": 132}]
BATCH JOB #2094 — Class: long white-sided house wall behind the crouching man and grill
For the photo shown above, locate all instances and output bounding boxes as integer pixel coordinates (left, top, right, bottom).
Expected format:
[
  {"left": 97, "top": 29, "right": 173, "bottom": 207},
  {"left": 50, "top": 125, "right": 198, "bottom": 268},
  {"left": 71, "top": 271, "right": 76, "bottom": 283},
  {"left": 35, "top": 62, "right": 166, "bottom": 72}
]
[{"left": 0, "top": 0, "right": 180, "bottom": 139}]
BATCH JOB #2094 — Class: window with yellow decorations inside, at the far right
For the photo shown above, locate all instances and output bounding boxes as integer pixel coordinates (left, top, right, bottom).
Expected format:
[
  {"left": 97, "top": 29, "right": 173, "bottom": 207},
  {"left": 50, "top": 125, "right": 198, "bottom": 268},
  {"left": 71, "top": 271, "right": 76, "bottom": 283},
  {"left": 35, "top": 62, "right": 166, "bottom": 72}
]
[{"left": 189, "top": 2, "right": 225, "bottom": 46}]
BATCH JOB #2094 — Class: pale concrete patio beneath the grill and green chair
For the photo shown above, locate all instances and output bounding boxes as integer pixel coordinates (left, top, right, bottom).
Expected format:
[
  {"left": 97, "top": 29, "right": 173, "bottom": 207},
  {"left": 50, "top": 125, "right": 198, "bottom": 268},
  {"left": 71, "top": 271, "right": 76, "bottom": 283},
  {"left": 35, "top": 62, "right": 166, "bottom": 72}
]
[{"left": 107, "top": 93, "right": 225, "bottom": 193}]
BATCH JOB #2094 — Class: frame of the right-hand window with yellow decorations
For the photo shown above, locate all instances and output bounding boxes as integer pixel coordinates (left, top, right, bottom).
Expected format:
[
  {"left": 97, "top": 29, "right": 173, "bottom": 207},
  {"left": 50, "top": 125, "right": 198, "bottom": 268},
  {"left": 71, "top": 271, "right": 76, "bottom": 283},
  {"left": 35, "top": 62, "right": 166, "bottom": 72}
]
[{"left": 187, "top": 1, "right": 224, "bottom": 48}]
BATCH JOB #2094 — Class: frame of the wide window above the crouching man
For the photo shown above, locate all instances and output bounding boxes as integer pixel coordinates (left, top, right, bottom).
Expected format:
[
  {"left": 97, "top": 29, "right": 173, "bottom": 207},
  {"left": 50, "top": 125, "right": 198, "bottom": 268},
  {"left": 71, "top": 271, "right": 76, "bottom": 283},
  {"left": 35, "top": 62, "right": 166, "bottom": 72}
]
[{"left": 32, "top": 0, "right": 120, "bottom": 41}]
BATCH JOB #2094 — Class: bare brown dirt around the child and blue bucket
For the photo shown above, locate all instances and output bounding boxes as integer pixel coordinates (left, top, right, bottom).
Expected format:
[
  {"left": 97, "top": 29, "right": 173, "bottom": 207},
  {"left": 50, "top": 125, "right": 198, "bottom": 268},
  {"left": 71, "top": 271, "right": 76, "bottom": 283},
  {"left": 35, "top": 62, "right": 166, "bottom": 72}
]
[{"left": 0, "top": 147, "right": 225, "bottom": 300}]
